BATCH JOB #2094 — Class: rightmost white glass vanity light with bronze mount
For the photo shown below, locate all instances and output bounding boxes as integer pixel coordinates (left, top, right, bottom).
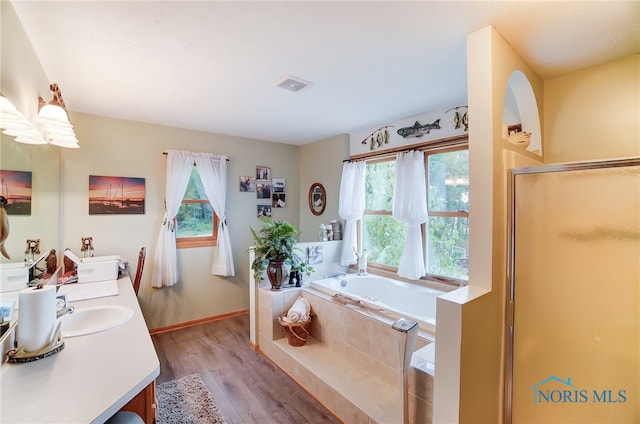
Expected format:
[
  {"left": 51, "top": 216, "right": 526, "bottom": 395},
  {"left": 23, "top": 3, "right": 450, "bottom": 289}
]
[{"left": 36, "top": 83, "right": 80, "bottom": 149}]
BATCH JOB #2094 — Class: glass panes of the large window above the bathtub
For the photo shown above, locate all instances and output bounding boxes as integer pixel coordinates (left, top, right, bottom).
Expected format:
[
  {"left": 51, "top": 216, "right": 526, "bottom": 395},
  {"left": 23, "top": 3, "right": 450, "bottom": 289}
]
[{"left": 361, "top": 145, "right": 469, "bottom": 281}]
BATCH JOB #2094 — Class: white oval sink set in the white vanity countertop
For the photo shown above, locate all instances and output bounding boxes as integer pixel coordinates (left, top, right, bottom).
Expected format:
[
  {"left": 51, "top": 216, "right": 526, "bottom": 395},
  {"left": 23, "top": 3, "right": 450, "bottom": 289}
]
[{"left": 60, "top": 305, "right": 133, "bottom": 337}]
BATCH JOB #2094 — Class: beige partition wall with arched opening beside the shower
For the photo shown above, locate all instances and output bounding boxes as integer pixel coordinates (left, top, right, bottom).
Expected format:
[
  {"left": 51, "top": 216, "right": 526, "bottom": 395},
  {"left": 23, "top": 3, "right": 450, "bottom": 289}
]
[{"left": 434, "top": 27, "right": 544, "bottom": 423}]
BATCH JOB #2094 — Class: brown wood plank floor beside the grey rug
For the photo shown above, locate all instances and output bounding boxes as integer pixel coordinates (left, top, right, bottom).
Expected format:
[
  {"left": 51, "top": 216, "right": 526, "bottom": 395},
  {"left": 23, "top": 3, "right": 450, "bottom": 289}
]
[{"left": 151, "top": 314, "right": 341, "bottom": 424}]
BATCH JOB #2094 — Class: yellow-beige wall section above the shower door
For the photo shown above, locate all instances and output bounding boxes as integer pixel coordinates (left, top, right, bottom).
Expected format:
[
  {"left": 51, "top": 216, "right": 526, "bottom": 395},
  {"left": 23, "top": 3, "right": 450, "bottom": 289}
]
[{"left": 544, "top": 55, "right": 640, "bottom": 163}]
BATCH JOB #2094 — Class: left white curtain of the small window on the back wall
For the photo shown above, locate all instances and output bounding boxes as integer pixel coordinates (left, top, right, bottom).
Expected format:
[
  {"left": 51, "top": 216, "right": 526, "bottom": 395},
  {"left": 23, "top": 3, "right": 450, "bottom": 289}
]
[{"left": 151, "top": 150, "right": 194, "bottom": 287}]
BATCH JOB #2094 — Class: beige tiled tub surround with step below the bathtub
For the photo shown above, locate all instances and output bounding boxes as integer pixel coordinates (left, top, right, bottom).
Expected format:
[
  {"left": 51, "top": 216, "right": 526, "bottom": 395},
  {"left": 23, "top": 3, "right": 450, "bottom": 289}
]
[{"left": 258, "top": 287, "right": 433, "bottom": 424}]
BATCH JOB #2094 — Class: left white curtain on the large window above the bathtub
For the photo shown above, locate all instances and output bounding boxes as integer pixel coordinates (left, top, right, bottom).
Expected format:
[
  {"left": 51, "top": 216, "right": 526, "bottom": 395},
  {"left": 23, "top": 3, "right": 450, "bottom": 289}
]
[{"left": 338, "top": 161, "right": 366, "bottom": 266}]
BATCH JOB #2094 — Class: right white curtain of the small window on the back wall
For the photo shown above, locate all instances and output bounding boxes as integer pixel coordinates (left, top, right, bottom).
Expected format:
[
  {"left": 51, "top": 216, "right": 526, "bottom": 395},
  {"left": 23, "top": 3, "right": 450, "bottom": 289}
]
[{"left": 195, "top": 153, "right": 236, "bottom": 277}]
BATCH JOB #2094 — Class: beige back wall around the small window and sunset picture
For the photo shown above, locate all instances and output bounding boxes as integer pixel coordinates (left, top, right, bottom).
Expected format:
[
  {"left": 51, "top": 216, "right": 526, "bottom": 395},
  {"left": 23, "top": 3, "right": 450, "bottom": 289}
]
[{"left": 61, "top": 113, "right": 300, "bottom": 329}]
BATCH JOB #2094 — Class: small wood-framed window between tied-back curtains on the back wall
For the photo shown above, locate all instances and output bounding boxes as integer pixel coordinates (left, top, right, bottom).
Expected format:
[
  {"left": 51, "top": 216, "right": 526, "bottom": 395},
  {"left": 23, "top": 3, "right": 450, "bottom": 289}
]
[{"left": 176, "top": 166, "right": 218, "bottom": 249}]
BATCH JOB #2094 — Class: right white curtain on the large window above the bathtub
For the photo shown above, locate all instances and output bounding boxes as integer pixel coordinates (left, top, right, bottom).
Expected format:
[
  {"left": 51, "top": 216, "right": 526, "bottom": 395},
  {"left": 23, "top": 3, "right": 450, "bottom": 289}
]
[{"left": 393, "top": 151, "right": 429, "bottom": 280}]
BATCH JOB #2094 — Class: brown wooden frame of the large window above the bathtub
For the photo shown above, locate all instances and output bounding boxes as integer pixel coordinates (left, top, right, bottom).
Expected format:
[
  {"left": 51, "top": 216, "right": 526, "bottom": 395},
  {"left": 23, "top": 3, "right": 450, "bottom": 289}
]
[{"left": 350, "top": 134, "right": 470, "bottom": 286}]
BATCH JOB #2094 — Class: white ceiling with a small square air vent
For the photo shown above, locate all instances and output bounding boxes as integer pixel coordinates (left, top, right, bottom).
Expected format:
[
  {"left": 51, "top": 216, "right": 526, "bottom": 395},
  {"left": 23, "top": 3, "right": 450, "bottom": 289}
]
[{"left": 11, "top": 0, "right": 640, "bottom": 145}]
